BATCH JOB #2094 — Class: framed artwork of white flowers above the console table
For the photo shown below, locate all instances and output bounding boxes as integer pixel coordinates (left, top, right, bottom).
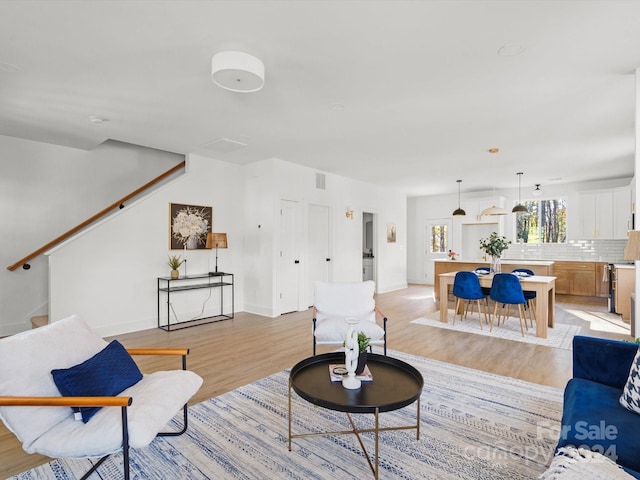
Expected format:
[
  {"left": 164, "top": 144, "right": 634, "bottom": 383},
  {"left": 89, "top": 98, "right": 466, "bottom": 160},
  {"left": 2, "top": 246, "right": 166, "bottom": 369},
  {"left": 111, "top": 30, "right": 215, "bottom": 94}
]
[{"left": 169, "top": 203, "right": 213, "bottom": 250}]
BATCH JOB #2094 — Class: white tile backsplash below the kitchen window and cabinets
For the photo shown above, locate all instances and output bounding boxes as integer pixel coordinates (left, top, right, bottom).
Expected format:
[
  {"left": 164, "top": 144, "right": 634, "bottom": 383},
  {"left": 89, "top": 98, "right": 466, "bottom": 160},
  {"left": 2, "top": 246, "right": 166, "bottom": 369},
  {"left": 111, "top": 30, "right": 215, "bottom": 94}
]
[{"left": 502, "top": 239, "right": 630, "bottom": 263}]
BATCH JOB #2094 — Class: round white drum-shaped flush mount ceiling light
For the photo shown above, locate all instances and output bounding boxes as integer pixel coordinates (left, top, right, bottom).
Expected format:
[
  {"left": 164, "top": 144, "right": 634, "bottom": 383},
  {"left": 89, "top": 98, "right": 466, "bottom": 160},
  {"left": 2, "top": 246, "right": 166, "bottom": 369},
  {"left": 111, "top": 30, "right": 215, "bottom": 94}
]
[{"left": 211, "top": 51, "right": 264, "bottom": 93}]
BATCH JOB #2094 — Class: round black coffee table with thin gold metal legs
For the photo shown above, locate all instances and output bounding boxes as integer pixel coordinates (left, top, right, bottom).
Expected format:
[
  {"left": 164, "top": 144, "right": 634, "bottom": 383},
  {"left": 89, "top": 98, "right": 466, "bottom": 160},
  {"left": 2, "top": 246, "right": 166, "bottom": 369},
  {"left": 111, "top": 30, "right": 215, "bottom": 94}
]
[{"left": 289, "top": 352, "right": 424, "bottom": 478}]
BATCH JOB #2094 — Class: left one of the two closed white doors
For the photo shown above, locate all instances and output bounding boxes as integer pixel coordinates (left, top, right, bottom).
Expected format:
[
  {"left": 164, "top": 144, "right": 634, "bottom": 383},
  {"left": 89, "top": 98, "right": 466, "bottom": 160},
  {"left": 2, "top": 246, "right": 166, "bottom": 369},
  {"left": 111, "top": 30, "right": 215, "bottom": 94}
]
[{"left": 277, "top": 200, "right": 301, "bottom": 314}]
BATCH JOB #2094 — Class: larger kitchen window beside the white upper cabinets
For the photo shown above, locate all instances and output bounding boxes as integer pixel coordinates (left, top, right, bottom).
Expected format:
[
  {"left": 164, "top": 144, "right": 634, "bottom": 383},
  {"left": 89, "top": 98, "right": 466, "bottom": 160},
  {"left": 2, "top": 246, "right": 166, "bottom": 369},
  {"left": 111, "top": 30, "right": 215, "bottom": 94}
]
[{"left": 516, "top": 198, "right": 567, "bottom": 243}]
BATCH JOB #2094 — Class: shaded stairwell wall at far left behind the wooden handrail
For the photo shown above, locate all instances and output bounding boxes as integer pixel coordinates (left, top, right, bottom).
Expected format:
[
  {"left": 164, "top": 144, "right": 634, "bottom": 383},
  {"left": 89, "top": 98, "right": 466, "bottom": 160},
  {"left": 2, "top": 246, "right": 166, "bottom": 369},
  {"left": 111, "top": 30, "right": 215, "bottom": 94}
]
[{"left": 0, "top": 135, "right": 184, "bottom": 336}]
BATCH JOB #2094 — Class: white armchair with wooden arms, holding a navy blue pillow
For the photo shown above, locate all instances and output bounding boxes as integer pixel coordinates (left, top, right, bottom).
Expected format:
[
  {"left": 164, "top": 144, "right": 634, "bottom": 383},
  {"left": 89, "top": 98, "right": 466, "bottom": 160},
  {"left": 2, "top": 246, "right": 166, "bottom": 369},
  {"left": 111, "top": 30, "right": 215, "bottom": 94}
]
[{"left": 0, "top": 315, "right": 202, "bottom": 479}]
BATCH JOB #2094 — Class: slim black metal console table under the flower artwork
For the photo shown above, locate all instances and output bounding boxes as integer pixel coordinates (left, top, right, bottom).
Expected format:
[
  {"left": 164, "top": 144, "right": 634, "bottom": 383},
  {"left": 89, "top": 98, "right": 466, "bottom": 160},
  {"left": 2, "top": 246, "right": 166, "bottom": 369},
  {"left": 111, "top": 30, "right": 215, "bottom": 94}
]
[{"left": 158, "top": 273, "right": 235, "bottom": 332}]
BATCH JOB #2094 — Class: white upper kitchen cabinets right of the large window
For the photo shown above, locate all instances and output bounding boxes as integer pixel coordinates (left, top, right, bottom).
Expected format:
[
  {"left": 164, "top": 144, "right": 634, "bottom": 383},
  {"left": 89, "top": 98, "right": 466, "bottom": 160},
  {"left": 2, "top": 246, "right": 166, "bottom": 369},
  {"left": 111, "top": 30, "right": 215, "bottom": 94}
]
[{"left": 577, "top": 188, "right": 631, "bottom": 239}]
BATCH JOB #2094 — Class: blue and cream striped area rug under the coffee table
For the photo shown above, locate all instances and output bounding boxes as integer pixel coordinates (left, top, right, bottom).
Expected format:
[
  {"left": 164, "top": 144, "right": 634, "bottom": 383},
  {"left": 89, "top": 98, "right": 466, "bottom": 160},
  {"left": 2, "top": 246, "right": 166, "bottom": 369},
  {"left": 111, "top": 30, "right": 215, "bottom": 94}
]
[{"left": 8, "top": 351, "right": 562, "bottom": 480}]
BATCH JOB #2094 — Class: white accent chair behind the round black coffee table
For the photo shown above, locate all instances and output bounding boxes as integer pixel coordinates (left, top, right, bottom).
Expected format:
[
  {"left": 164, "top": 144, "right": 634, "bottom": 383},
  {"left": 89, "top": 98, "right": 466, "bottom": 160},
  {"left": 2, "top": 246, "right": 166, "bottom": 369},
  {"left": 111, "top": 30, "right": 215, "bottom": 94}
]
[{"left": 313, "top": 280, "right": 387, "bottom": 355}]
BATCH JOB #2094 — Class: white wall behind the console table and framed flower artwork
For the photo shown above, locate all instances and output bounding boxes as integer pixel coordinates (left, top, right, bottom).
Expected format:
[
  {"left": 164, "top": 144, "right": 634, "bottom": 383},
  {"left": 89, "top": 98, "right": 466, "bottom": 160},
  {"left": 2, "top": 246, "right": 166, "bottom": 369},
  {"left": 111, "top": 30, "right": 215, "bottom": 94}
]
[{"left": 49, "top": 155, "right": 244, "bottom": 336}]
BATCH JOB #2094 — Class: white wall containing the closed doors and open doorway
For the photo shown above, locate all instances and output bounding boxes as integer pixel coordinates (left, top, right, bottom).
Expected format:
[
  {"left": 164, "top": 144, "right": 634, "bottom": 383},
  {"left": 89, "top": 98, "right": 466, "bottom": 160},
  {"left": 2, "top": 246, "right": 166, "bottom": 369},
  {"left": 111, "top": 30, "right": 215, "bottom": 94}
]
[{"left": 240, "top": 159, "right": 407, "bottom": 316}]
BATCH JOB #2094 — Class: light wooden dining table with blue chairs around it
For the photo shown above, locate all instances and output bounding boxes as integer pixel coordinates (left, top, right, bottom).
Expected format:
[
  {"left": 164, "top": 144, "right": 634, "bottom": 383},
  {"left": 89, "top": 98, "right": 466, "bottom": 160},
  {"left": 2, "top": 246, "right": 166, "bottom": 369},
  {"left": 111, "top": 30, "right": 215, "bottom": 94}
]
[{"left": 439, "top": 272, "right": 556, "bottom": 338}]
